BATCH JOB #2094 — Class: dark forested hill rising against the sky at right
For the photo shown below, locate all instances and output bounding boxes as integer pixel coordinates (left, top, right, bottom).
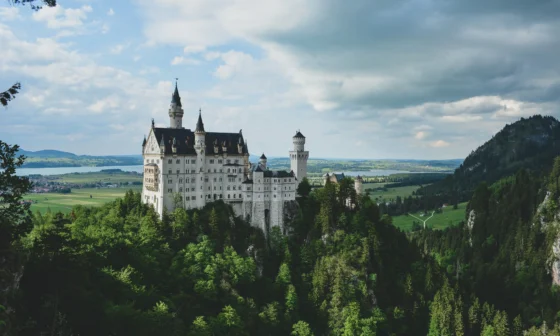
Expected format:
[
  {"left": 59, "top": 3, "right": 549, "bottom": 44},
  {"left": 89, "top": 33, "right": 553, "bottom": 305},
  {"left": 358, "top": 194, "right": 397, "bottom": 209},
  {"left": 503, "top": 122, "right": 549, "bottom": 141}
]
[{"left": 421, "top": 115, "right": 560, "bottom": 199}]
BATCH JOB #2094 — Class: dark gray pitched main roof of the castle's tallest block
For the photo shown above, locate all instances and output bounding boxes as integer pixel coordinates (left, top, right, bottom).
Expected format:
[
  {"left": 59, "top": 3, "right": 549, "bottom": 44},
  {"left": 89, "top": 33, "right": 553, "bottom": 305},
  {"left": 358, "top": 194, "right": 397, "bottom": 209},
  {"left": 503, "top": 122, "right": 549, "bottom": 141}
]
[{"left": 153, "top": 128, "right": 249, "bottom": 155}]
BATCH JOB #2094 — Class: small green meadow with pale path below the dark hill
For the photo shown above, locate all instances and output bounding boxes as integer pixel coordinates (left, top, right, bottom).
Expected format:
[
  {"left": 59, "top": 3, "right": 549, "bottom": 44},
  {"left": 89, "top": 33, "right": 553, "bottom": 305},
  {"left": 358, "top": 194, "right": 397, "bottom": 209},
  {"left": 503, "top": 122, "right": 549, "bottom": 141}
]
[{"left": 393, "top": 202, "right": 467, "bottom": 231}]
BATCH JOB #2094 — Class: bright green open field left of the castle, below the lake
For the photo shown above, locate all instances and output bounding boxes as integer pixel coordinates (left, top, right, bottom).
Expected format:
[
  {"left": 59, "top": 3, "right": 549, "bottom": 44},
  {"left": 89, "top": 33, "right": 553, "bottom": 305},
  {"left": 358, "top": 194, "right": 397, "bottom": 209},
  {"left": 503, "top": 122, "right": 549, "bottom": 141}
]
[{"left": 24, "top": 186, "right": 141, "bottom": 213}]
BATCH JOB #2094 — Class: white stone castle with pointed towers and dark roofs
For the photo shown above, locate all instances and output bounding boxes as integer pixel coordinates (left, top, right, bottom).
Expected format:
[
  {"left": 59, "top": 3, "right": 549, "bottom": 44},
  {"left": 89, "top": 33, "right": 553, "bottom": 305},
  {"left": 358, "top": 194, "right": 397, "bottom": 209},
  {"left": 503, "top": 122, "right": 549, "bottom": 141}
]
[{"left": 142, "top": 83, "right": 309, "bottom": 232}]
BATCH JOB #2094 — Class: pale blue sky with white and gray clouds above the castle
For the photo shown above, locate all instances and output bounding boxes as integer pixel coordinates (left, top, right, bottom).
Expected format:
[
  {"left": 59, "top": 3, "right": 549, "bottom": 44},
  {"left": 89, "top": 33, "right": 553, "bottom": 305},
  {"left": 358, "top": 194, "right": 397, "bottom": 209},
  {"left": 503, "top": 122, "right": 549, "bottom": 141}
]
[{"left": 0, "top": 0, "right": 560, "bottom": 159}]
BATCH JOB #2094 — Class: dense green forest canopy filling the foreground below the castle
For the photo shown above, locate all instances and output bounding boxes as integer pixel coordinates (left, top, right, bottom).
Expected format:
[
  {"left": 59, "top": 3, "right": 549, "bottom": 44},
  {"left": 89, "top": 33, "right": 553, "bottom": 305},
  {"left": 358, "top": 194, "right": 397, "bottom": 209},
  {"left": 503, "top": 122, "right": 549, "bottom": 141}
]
[{"left": 4, "top": 116, "right": 560, "bottom": 336}]
